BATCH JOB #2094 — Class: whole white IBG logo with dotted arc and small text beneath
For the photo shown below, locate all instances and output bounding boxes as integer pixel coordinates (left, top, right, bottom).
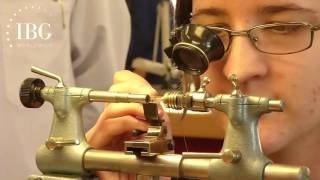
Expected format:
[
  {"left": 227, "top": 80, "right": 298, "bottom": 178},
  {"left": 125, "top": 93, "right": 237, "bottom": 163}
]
[{"left": 5, "top": 5, "right": 59, "bottom": 48}]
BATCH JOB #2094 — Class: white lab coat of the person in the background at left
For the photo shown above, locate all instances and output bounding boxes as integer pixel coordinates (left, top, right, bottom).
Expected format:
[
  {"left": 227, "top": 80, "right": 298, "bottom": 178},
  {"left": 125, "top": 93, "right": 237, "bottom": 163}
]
[{"left": 0, "top": 0, "right": 130, "bottom": 180}]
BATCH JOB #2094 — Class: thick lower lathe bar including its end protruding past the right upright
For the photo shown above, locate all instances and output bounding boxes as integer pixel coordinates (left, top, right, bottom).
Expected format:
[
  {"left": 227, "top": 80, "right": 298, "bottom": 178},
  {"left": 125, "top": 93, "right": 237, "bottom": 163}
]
[{"left": 84, "top": 150, "right": 310, "bottom": 180}]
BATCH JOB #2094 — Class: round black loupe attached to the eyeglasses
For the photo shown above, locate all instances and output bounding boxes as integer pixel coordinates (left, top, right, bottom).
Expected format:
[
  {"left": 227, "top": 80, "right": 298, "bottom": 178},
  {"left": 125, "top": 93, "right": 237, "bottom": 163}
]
[{"left": 165, "top": 24, "right": 225, "bottom": 75}]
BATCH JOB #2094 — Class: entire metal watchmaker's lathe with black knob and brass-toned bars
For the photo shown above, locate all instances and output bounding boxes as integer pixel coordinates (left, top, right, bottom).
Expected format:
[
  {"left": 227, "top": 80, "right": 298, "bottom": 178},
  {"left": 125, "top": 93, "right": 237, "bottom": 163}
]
[{"left": 20, "top": 67, "right": 309, "bottom": 180}]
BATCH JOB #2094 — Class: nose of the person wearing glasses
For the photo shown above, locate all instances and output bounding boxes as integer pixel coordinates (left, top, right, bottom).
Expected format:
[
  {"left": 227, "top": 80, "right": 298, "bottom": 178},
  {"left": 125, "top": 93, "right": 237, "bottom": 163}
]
[{"left": 223, "top": 36, "right": 268, "bottom": 84}]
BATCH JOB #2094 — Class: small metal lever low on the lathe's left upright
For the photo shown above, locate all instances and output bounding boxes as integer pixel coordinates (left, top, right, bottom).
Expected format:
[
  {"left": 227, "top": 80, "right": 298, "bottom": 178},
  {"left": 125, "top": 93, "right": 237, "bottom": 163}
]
[{"left": 46, "top": 137, "right": 80, "bottom": 151}]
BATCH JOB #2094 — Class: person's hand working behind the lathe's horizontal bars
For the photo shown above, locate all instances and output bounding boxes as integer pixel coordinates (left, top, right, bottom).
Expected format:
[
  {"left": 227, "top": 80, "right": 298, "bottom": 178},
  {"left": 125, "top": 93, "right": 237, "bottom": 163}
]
[{"left": 86, "top": 71, "right": 156, "bottom": 179}]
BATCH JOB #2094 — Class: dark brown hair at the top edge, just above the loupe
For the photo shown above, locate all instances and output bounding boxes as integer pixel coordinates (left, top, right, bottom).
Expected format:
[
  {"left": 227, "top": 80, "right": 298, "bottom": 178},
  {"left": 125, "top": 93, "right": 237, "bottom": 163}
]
[{"left": 175, "top": 0, "right": 192, "bottom": 27}]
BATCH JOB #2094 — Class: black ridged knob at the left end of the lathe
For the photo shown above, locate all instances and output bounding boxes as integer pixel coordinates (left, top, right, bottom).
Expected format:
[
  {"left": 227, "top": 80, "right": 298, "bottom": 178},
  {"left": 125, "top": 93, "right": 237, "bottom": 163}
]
[{"left": 19, "top": 78, "right": 45, "bottom": 108}]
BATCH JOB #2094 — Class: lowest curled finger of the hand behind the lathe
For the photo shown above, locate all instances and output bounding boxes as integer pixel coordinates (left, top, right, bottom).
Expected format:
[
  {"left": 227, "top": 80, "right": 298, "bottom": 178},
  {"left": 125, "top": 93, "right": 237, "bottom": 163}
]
[{"left": 87, "top": 116, "right": 148, "bottom": 149}]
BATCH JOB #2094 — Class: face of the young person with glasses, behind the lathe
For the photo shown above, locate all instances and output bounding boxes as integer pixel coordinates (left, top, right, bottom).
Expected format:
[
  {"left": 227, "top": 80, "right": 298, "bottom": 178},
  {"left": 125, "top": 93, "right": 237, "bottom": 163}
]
[{"left": 192, "top": 0, "right": 320, "bottom": 154}]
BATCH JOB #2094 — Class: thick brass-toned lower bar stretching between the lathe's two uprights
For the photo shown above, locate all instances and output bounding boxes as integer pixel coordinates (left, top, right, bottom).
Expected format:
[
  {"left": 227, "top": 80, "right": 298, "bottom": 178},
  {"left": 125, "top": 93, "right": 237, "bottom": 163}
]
[{"left": 84, "top": 150, "right": 210, "bottom": 178}]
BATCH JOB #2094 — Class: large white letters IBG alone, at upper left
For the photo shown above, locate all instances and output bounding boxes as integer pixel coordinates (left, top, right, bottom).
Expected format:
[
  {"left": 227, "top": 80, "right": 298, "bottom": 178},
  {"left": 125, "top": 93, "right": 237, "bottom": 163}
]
[{"left": 16, "top": 23, "right": 52, "bottom": 40}]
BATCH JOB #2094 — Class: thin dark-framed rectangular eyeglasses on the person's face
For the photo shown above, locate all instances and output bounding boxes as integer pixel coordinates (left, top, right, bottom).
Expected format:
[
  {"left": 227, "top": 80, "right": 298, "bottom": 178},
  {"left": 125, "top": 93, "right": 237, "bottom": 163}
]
[{"left": 206, "top": 22, "right": 320, "bottom": 55}]
